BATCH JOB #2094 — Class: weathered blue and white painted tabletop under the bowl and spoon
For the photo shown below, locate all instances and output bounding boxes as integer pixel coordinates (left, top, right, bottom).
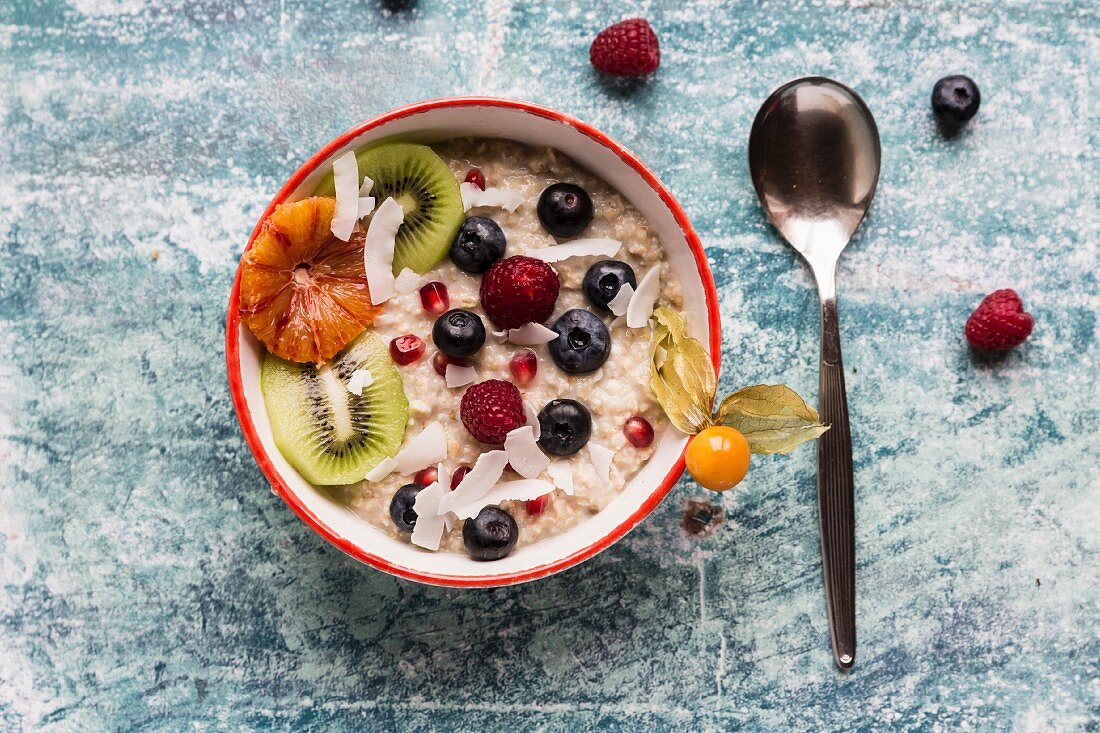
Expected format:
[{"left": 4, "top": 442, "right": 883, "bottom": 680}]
[{"left": 0, "top": 0, "right": 1100, "bottom": 731}]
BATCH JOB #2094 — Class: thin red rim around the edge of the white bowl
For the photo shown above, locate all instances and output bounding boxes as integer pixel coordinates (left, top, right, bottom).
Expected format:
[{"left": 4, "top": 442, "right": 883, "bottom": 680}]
[{"left": 226, "top": 97, "right": 722, "bottom": 588}]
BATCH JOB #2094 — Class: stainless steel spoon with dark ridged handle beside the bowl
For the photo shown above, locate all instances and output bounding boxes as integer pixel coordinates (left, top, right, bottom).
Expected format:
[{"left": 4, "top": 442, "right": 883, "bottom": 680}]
[{"left": 749, "top": 76, "right": 880, "bottom": 669}]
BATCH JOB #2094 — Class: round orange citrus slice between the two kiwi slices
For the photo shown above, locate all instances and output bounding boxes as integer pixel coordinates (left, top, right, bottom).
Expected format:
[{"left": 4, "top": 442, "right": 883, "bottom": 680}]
[{"left": 241, "top": 197, "right": 382, "bottom": 364}]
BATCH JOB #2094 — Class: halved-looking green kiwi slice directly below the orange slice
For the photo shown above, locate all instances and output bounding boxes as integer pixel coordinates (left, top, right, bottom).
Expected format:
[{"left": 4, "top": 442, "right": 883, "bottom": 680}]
[{"left": 260, "top": 331, "right": 409, "bottom": 485}]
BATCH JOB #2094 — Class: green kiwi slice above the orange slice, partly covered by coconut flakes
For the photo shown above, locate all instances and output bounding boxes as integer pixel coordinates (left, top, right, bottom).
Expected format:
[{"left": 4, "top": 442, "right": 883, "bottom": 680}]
[{"left": 314, "top": 143, "right": 466, "bottom": 275}]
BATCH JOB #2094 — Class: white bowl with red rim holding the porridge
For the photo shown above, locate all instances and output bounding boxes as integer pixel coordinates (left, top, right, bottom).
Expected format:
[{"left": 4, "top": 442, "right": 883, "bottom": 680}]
[{"left": 226, "top": 97, "right": 721, "bottom": 587}]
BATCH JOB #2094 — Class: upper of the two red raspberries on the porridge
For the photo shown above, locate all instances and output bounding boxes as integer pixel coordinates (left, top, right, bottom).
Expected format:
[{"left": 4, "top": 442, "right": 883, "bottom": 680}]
[{"left": 481, "top": 254, "right": 560, "bottom": 328}]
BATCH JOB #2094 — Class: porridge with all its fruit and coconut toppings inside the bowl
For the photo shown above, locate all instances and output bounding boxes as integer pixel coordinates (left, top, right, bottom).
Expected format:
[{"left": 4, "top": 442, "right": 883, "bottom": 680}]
[{"left": 240, "top": 140, "right": 682, "bottom": 561}]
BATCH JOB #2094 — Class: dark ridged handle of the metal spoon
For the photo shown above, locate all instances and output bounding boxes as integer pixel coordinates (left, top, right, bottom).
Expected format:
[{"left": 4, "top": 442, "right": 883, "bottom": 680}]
[{"left": 817, "top": 297, "right": 856, "bottom": 669}]
